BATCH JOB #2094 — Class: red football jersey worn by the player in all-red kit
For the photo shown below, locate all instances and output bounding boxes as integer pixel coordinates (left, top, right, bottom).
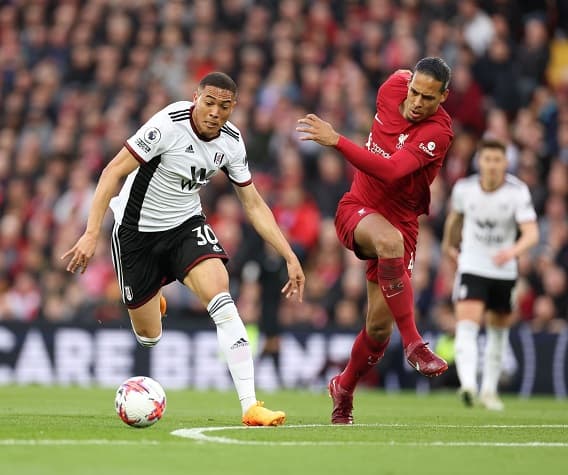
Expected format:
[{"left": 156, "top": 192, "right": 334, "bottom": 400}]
[{"left": 337, "top": 71, "right": 453, "bottom": 222}]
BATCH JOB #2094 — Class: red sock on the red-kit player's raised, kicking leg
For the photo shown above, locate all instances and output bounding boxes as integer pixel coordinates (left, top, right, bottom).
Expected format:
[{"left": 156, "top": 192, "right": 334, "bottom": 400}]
[{"left": 378, "top": 257, "right": 422, "bottom": 348}]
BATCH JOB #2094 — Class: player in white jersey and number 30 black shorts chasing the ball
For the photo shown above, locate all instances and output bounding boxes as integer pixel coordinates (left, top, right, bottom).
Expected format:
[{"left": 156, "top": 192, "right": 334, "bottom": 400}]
[{"left": 62, "top": 72, "right": 305, "bottom": 426}]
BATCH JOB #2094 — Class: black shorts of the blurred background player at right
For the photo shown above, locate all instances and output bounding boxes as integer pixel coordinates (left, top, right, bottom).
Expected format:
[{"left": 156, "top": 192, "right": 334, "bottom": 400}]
[{"left": 453, "top": 274, "right": 515, "bottom": 313}]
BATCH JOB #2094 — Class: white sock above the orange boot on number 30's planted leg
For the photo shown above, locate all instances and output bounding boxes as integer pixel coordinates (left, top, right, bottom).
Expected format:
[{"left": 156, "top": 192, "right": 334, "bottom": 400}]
[{"left": 207, "top": 292, "right": 256, "bottom": 414}]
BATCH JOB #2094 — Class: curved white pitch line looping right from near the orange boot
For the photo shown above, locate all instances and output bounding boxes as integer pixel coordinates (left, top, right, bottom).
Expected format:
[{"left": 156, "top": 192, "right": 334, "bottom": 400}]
[{"left": 171, "top": 424, "right": 568, "bottom": 447}]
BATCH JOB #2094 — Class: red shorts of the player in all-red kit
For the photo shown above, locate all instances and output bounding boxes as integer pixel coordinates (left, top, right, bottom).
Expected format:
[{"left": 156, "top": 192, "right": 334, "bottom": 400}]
[{"left": 335, "top": 195, "right": 418, "bottom": 282}]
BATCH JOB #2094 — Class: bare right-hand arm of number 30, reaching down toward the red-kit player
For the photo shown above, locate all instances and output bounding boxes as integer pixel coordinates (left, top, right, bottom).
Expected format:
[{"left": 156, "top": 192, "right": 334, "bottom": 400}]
[{"left": 235, "top": 184, "right": 306, "bottom": 302}]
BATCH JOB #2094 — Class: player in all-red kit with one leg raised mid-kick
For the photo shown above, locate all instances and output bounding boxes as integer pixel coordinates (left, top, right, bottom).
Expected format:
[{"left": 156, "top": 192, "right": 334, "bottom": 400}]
[{"left": 297, "top": 57, "right": 453, "bottom": 424}]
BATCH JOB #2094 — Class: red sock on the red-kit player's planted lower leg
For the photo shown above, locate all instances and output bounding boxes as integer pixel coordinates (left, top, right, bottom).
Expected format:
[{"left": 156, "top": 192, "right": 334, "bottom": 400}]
[{"left": 339, "top": 328, "right": 390, "bottom": 392}]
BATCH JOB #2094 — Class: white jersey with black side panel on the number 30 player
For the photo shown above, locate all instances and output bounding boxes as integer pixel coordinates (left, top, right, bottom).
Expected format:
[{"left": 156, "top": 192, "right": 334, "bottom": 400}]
[{"left": 110, "top": 101, "right": 252, "bottom": 232}]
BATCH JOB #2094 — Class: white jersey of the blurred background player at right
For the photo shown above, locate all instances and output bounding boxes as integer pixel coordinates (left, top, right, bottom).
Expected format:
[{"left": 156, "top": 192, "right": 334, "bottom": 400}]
[{"left": 452, "top": 174, "right": 536, "bottom": 280}]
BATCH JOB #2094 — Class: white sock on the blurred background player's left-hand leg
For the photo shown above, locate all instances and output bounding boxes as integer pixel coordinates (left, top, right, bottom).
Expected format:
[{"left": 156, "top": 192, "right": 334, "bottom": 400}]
[{"left": 455, "top": 320, "right": 479, "bottom": 391}]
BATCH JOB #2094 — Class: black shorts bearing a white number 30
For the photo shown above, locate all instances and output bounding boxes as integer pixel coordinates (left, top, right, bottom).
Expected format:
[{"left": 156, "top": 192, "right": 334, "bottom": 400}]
[{"left": 111, "top": 215, "right": 229, "bottom": 308}]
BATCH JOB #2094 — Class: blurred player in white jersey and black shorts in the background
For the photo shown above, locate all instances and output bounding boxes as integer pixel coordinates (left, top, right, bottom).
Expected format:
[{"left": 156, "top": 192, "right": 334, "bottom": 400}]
[{"left": 442, "top": 140, "right": 538, "bottom": 411}]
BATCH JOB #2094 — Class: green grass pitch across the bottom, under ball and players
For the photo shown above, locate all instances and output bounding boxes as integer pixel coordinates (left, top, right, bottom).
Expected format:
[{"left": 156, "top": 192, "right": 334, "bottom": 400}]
[{"left": 0, "top": 386, "right": 568, "bottom": 475}]
